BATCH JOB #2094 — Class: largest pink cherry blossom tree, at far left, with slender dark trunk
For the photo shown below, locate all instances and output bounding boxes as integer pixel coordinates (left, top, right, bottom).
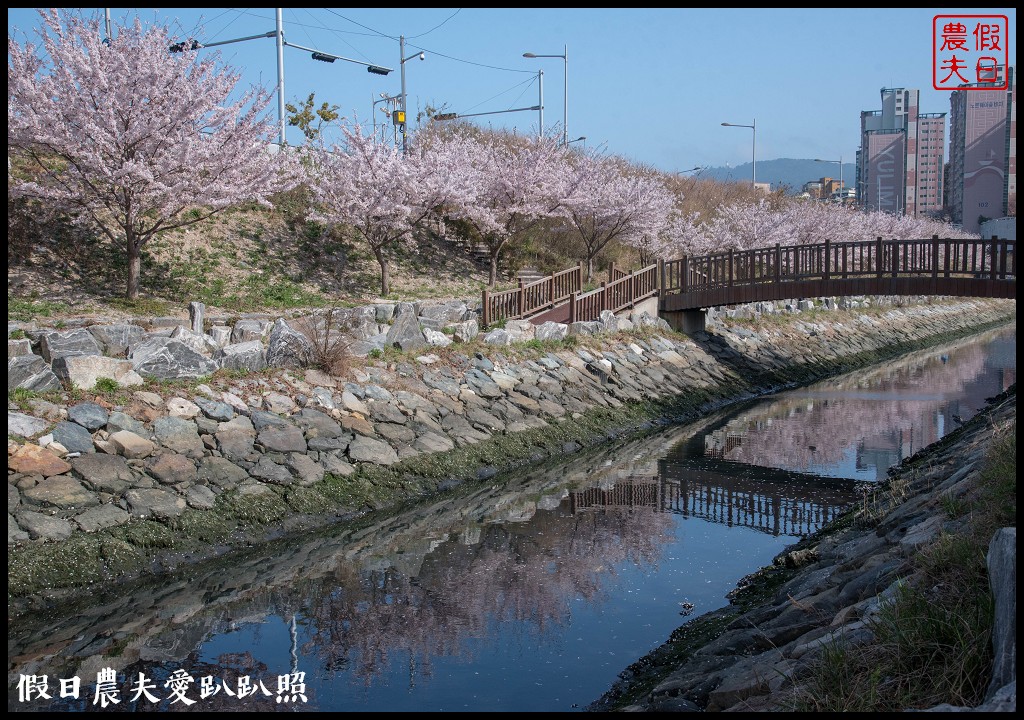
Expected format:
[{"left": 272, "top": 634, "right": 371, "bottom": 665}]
[{"left": 7, "top": 9, "right": 293, "bottom": 299}]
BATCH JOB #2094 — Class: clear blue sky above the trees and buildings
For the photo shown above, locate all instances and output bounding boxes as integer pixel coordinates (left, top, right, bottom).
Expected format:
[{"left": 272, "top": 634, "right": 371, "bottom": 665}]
[{"left": 7, "top": 6, "right": 1017, "bottom": 171}]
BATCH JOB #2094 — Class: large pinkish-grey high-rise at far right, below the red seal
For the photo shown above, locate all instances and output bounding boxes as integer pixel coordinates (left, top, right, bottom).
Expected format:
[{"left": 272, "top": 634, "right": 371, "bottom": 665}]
[{"left": 949, "top": 66, "right": 1017, "bottom": 232}]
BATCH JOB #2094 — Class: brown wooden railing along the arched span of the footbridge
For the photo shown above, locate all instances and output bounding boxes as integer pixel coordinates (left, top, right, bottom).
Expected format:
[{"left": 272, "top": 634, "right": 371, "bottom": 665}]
[{"left": 662, "top": 236, "right": 1017, "bottom": 293}]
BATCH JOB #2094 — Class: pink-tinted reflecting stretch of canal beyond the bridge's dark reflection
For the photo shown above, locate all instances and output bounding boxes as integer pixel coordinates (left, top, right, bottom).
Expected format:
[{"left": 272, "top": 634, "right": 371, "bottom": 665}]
[{"left": 705, "top": 330, "right": 1017, "bottom": 480}]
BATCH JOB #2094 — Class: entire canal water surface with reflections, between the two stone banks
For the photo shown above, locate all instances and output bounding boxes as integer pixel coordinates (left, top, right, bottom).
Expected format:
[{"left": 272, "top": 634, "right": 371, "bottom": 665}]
[{"left": 8, "top": 325, "right": 1016, "bottom": 712}]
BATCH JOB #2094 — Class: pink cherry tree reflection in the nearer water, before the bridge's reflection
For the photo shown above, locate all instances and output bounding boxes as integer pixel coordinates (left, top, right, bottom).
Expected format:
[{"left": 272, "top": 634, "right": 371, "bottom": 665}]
[{"left": 303, "top": 507, "right": 672, "bottom": 684}]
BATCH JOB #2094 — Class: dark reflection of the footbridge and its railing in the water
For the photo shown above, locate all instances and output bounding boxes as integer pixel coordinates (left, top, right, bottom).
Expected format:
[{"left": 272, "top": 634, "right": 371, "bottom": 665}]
[{"left": 568, "top": 459, "right": 855, "bottom": 537}]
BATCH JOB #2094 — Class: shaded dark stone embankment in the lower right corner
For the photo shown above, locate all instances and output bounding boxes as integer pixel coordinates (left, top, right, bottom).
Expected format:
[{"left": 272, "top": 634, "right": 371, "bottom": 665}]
[{"left": 589, "top": 390, "right": 1017, "bottom": 712}]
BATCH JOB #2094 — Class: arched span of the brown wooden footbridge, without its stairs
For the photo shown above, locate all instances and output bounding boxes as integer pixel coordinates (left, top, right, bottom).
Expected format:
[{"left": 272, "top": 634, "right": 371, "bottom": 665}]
[{"left": 659, "top": 236, "right": 1017, "bottom": 312}]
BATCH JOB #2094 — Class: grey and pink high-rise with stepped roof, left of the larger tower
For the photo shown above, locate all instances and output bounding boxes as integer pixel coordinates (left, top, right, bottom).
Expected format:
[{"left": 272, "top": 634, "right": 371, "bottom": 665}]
[{"left": 857, "top": 87, "right": 946, "bottom": 217}]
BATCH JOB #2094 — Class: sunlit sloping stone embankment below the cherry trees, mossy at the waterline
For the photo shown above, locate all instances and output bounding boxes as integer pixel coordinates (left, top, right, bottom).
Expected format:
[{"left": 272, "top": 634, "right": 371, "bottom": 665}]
[{"left": 8, "top": 300, "right": 1016, "bottom": 596}]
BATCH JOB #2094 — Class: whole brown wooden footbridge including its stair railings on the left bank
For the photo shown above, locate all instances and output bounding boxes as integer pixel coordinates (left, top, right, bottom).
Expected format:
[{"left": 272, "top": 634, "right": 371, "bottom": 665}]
[{"left": 482, "top": 236, "right": 1017, "bottom": 327}]
